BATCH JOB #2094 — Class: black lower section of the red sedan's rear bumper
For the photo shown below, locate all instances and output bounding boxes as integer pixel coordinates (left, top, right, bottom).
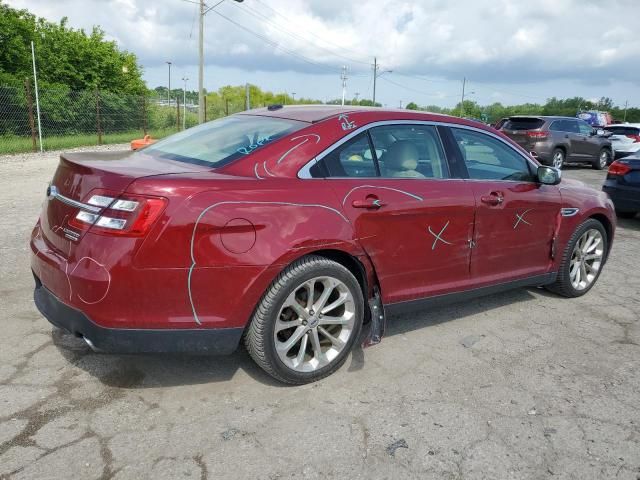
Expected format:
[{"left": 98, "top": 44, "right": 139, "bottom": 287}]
[{"left": 33, "top": 275, "right": 243, "bottom": 355}]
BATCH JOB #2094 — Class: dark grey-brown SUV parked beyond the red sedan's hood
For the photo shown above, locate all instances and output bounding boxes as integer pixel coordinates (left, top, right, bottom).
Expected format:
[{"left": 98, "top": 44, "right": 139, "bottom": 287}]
[{"left": 501, "top": 116, "right": 613, "bottom": 170}]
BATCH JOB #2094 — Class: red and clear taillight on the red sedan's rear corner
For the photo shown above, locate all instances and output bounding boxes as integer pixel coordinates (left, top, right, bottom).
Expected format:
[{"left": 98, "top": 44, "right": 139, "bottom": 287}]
[{"left": 69, "top": 192, "right": 167, "bottom": 237}]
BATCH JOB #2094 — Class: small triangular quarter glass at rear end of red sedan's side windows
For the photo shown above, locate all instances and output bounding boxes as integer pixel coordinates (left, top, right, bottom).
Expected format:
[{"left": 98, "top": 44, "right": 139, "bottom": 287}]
[{"left": 311, "top": 133, "right": 378, "bottom": 177}]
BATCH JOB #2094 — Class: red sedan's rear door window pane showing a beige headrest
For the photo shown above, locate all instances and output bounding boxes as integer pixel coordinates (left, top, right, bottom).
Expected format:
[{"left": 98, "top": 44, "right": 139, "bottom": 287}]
[{"left": 370, "top": 125, "right": 449, "bottom": 178}]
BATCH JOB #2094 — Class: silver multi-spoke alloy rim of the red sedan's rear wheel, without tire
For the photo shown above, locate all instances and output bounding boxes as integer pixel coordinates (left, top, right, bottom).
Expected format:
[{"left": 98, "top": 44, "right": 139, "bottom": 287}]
[{"left": 273, "top": 276, "right": 356, "bottom": 372}]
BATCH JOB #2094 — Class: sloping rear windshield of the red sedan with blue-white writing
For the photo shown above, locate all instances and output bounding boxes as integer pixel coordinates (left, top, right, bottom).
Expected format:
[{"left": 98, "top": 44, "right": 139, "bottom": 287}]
[{"left": 144, "top": 115, "right": 307, "bottom": 168}]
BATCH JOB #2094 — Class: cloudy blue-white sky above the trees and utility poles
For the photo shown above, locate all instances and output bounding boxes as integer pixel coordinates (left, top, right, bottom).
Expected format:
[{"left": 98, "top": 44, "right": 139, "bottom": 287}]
[{"left": 5, "top": 0, "right": 640, "bottom": 106}]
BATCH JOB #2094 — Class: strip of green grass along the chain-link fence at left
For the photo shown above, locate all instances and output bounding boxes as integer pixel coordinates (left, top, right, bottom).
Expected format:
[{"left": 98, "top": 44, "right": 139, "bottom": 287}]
[{"left": 0, "top": 128, "right": 177, "bottom": 155}]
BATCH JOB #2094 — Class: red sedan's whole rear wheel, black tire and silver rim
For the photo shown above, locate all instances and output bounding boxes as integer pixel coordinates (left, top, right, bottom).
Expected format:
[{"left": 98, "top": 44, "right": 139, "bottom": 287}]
[{"left": 245, "top": 255, "right": 364, "bottom": 385}]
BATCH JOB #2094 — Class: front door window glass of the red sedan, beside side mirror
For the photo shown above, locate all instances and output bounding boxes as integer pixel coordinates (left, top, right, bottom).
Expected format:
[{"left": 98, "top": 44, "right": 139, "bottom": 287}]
[{"left": 451, "top": 128, "right": 533, "bottom": 181}]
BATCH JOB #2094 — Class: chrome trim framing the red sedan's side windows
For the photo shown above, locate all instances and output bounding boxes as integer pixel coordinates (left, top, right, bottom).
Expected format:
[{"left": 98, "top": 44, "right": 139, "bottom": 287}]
[{"left": 297, "top": 120, "right": 538, "bottom": 183}]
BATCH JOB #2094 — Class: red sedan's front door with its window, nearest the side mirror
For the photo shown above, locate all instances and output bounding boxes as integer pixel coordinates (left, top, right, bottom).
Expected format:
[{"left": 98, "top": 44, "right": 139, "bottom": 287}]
[{"left": 449, "top": 127, "right": 561, "bottom": 286}]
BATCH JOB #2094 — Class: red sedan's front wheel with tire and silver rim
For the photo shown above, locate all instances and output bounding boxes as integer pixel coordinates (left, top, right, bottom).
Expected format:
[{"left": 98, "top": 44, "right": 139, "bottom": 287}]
[{"left": 547, "top": 218, "right": 608, "bottom": 298}]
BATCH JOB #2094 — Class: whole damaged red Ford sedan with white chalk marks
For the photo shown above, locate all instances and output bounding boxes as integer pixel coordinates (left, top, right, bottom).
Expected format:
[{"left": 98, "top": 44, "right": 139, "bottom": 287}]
[{"left": 31, "top": 106, "right": 615, "bottom": 383}]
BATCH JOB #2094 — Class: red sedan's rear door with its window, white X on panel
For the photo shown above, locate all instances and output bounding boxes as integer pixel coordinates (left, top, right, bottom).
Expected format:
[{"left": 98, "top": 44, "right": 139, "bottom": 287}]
[{"left": 310, "top": 123, "right": 475, "bottom": 305}]
